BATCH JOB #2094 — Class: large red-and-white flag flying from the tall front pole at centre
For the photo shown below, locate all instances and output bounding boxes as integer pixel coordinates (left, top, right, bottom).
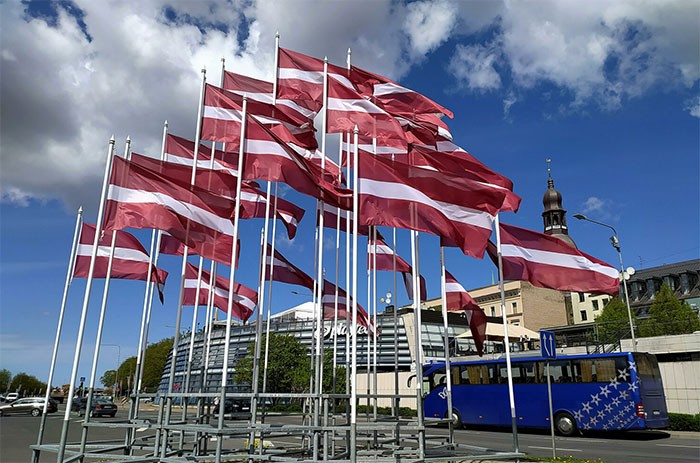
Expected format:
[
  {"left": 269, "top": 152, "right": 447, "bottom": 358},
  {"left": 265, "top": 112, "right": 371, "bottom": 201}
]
[{"left": 358, "top": 153, "right": 505, "bottom": 258}]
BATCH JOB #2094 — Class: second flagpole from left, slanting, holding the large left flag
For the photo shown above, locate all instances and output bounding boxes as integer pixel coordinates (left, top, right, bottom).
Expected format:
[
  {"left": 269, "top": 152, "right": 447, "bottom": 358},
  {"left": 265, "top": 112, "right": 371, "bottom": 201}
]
[{"left": 56, "top": 136, "right": 115, "bottom": 463}]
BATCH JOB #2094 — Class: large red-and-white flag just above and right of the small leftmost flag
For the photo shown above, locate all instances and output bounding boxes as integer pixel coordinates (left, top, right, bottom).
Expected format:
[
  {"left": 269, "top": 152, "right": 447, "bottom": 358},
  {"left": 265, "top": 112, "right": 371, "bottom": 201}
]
[{"left": 105, "top": 157, "right": 235, "bottom": 262}]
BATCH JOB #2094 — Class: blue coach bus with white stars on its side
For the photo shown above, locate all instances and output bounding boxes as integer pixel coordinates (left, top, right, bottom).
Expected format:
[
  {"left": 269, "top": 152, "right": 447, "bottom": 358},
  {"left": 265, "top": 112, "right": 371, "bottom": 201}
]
[{"left": 423, "top": 352, "right": 669, "bottom": 436}]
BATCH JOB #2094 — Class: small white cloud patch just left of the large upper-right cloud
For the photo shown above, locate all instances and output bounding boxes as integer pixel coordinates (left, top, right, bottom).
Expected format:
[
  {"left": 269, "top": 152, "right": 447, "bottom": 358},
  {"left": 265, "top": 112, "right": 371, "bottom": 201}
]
[{"left": 448, "top": 45, "right": 501, "bottom": 91}]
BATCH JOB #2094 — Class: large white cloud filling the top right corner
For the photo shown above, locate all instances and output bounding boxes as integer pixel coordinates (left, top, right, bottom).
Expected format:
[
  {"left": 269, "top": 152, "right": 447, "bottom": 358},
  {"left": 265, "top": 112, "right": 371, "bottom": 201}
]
[{"left": 452, "top": 0, "right": 700, "bottom": 109}]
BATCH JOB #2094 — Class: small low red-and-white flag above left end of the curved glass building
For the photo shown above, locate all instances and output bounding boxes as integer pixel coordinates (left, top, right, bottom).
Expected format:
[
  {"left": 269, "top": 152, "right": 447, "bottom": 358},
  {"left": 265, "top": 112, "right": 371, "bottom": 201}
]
[{"left": 182, "top": 263, "right": 258, "bottom": 322}]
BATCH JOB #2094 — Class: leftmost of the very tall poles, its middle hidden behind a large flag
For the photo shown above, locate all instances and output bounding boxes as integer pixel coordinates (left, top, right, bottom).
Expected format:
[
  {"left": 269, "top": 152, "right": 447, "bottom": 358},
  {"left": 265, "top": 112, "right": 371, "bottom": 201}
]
[{"left": 161, "top": 69, "right": 202, "bottom": 458}]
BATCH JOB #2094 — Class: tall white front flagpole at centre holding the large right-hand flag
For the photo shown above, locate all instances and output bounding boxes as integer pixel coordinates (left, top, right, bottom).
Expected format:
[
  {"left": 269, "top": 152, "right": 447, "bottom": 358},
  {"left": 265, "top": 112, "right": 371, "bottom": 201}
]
[{"left": 348, "top": 125, "right": 359, "bottom": 461}]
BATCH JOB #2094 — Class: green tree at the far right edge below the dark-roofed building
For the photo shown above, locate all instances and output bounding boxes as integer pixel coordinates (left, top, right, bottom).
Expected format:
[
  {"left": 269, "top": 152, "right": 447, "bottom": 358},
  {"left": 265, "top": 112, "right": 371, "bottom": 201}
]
[{"left": 640, "top": 284, "right": 700, "bottom": 336}]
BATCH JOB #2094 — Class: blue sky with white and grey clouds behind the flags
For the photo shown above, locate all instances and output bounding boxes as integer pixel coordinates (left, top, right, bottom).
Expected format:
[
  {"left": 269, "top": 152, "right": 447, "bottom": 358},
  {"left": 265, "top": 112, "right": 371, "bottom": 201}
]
[{"left": 0, "top": 0, "right": 700, "bottom": 390}]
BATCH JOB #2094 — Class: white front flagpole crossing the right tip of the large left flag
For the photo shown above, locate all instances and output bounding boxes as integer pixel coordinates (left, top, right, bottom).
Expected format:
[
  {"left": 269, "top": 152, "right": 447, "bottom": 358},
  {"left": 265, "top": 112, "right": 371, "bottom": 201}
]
[{"left": 215, "top": 96, "right": 246, "bottom": 463}]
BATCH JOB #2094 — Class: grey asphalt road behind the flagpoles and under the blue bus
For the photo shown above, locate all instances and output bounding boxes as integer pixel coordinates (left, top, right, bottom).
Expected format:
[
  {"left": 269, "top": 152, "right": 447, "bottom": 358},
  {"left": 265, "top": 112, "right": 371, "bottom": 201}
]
[{"left": 0, "top": 407, "right": 700, "bottom": 463}]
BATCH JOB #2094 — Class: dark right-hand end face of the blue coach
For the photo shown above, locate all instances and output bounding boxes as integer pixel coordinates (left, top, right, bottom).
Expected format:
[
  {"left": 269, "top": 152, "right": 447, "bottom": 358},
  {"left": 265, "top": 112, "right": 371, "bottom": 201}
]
[{"left": 630, "top": 352, "right": 669, "bottom": 428}]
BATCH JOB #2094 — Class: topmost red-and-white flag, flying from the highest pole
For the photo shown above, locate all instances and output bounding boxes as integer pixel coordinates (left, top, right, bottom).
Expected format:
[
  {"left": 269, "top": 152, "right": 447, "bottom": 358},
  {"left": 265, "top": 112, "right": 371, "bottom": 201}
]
[{"left": 277, "top": 48, "right": 354, "bottom": 104}]
